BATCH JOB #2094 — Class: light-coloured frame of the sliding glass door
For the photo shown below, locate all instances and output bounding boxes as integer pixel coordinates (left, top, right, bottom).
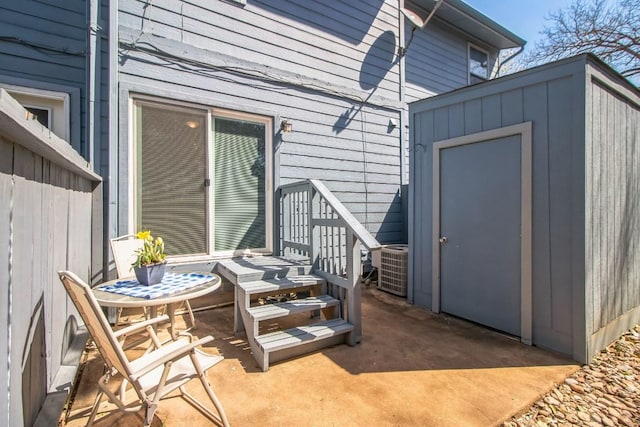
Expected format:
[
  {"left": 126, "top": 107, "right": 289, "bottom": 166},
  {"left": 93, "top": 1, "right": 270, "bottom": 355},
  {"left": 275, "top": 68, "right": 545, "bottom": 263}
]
[{"left": 127, "top": 96, "right": 275, "bottom": 262}]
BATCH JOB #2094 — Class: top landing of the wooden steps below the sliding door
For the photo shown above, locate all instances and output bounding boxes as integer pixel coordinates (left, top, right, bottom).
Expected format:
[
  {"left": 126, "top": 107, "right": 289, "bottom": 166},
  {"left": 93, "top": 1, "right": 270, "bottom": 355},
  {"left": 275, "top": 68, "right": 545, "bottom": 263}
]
[{"left": 215, "top": 256, "right": 311, "bottom": 285}]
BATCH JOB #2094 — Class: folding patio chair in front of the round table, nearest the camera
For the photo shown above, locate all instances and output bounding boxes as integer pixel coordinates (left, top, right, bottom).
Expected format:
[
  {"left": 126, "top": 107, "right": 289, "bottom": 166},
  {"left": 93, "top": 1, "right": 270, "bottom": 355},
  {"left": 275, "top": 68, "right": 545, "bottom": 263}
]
[{"left": 58, "top": 271, "right": 229, "bottom": 427}]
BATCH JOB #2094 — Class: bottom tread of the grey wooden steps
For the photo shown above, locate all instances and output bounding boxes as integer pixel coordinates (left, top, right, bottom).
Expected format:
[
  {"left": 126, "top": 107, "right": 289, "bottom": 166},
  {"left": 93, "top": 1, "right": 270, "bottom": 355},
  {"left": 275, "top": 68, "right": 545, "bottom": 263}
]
[{"left": 255, "top": 318, "right": 353, "bottom": 353}]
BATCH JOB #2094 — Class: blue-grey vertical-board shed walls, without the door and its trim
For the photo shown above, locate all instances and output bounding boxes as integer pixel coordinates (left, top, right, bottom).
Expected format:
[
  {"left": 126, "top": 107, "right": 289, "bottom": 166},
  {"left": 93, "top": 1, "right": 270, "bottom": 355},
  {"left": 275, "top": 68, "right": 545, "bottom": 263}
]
[{"left": 409, "top": 52, "right": 640, "bottom": 362}]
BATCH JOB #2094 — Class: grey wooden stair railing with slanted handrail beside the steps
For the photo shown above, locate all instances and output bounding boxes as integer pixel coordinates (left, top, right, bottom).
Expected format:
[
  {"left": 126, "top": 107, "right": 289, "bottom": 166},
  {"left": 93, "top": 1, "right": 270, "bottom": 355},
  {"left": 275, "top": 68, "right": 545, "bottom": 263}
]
[{"left": 278, "top": 179, "right": 380, "bottom": 345}]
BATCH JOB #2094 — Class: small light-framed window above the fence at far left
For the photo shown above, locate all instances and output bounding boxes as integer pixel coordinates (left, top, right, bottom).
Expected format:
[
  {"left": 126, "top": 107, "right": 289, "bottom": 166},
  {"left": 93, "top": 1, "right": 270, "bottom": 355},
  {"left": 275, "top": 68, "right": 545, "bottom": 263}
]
[{"left": 0, "top": 85, "right": 70, "bottom": 141}]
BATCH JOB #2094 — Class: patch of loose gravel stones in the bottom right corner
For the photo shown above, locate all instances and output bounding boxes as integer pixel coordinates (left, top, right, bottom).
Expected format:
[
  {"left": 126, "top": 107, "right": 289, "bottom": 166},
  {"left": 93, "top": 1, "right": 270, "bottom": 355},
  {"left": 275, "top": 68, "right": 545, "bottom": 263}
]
[{"left": 502, "top": 325, "right": 640, "bottom": 427}]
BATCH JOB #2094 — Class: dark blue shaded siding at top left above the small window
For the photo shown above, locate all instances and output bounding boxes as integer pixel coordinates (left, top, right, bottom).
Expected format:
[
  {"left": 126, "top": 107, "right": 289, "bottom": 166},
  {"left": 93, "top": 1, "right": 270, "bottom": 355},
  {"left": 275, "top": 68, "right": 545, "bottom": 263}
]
[{"left": 0, "top": 0, "right": 87, "bottom": 151}]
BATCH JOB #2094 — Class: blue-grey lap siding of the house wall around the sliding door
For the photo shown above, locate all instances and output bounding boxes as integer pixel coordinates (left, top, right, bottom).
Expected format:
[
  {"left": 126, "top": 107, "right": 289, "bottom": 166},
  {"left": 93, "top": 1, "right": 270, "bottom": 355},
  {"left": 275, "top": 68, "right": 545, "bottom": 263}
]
[{"left": 110, "top": 0, "right": 504, "bottom": 243}]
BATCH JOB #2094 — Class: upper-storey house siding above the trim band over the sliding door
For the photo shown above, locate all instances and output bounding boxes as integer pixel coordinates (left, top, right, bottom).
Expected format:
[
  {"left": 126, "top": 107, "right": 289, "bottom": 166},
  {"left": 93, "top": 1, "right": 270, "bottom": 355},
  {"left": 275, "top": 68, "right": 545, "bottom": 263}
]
[{"left": 119, "top": 0, "right": 399, "bottom": 99}]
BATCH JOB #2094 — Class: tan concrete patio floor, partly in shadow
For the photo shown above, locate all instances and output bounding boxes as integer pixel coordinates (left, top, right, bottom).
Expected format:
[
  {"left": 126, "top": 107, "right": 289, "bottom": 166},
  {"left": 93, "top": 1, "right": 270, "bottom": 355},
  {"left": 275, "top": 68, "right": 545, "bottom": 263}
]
[{"left": 61, "top": 288, "right": 579, "bottom": 427}]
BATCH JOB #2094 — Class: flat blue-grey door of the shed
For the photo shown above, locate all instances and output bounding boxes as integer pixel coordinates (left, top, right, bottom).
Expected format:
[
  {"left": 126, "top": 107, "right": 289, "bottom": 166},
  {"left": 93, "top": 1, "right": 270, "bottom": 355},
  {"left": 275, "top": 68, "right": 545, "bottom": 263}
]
[{"left": 440, "top": 135, "right": 522, "bottom": 336}]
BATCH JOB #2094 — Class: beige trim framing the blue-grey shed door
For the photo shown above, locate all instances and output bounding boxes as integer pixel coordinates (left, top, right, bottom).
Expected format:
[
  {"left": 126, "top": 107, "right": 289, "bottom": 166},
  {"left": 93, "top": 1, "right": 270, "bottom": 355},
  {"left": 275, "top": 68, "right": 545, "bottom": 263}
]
[{"left": 431, "top": 122, "right": 533, "bottom": 345}]
